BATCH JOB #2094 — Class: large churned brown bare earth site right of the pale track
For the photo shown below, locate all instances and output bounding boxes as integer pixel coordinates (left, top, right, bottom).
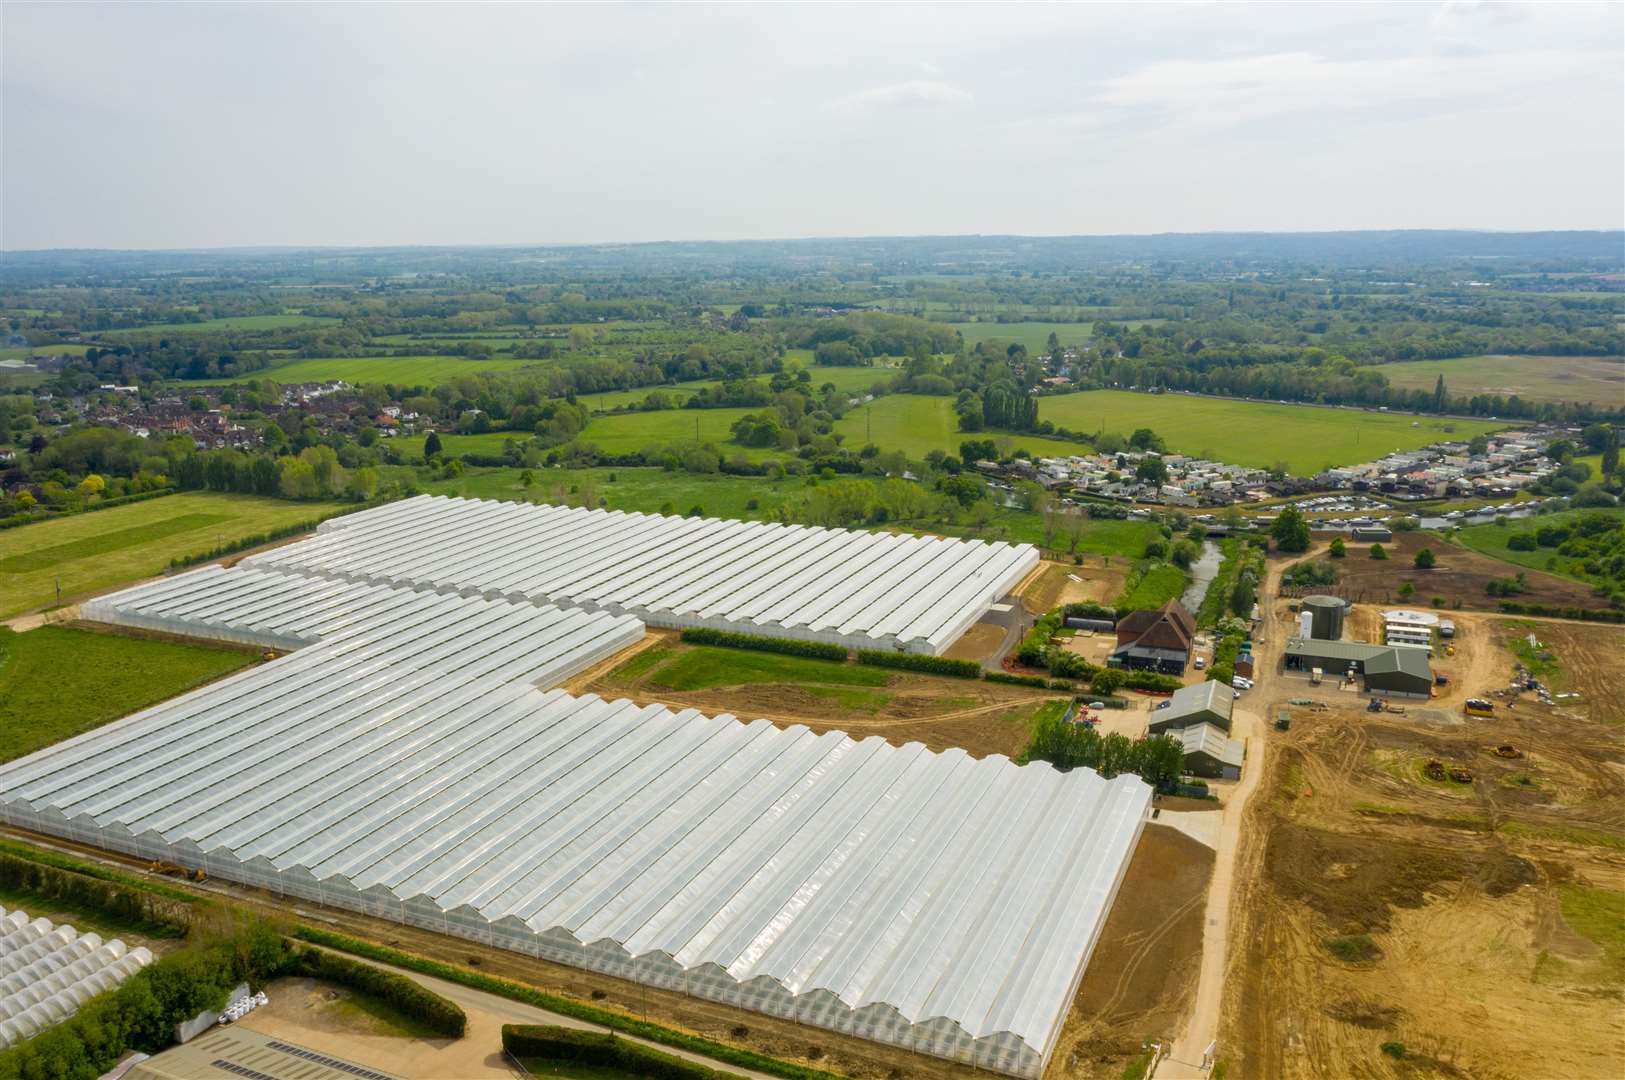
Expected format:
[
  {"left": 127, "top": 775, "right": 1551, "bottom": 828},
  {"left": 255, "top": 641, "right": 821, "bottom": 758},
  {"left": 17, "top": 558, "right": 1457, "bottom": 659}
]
[{"left": 1219, "top": 613, "right": 1625, "bottom": 1078}]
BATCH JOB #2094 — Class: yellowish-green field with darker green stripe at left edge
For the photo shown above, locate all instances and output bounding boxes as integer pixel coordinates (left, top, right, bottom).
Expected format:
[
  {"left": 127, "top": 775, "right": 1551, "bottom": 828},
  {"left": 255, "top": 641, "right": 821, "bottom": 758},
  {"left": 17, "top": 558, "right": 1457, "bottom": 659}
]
[{"left": 0, "top": 492, "right": 340, "bottom": 617}]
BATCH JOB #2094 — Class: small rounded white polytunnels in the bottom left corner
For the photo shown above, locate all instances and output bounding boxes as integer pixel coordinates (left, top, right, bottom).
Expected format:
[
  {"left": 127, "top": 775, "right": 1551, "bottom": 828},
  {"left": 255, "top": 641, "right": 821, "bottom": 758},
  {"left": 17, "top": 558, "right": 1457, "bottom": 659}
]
[{"left": 0, "top": 908, "right": 153, "bottom": 1048}]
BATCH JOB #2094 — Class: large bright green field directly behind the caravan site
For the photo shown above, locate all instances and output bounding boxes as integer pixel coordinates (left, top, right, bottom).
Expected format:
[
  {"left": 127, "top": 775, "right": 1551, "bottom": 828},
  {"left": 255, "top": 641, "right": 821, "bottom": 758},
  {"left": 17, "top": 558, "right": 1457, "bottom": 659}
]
[{"left": 1038, "top": 390, "right": 1506, "bottom": 476}]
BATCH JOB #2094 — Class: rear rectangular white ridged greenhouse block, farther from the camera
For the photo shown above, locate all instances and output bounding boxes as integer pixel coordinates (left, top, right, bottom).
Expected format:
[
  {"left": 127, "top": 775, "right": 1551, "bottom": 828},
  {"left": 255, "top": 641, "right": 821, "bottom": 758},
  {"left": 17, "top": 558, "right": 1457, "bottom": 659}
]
[{"left": 245, "top": 495, "right": 1038, "bottom": 654}]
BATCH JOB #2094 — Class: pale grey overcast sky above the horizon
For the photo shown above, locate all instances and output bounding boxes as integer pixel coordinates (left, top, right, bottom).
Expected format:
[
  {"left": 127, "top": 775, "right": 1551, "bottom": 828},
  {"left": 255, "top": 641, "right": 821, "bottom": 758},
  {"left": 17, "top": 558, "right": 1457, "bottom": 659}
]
[{"left": 0, "top": 2, "right": 1625, "bottom": 250}]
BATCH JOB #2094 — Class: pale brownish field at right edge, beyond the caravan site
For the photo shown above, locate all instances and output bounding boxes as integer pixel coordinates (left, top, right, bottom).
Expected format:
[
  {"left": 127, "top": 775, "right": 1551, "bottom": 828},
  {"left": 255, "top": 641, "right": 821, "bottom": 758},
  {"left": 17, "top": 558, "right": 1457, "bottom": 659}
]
[{"left": 1376, "top": 356, "right": 1625, "bottom": 408}]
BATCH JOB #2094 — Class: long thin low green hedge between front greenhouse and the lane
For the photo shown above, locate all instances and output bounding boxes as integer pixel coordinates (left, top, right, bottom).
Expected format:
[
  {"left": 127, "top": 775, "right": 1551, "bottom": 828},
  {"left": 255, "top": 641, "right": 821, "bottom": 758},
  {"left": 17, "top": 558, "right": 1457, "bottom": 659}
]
[{"left": 290, "top": 926, "right": 835, "bottom": 1080}]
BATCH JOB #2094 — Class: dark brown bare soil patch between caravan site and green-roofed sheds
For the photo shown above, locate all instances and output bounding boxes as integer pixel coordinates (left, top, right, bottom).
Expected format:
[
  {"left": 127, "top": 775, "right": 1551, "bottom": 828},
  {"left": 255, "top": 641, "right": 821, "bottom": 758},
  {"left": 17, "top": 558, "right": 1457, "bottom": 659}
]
[{"left": 1307, "top": 533, "right": 1607, "bottom": 611}]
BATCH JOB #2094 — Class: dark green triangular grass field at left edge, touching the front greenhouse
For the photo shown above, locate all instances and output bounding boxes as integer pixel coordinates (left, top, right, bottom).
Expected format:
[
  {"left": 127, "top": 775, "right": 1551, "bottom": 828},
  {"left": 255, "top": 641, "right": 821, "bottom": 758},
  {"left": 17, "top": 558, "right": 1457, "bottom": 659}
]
[{"left": 0, "top": 620, "right": 254, "bottom": 762}]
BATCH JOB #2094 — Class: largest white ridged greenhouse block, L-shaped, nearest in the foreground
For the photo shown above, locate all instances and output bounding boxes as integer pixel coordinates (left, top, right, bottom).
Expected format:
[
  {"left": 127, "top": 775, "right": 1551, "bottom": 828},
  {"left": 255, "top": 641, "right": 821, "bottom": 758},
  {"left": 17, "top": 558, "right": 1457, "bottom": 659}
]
[{"left": 0, "top": 568, "right": 1151, "bottom": 1077}]
